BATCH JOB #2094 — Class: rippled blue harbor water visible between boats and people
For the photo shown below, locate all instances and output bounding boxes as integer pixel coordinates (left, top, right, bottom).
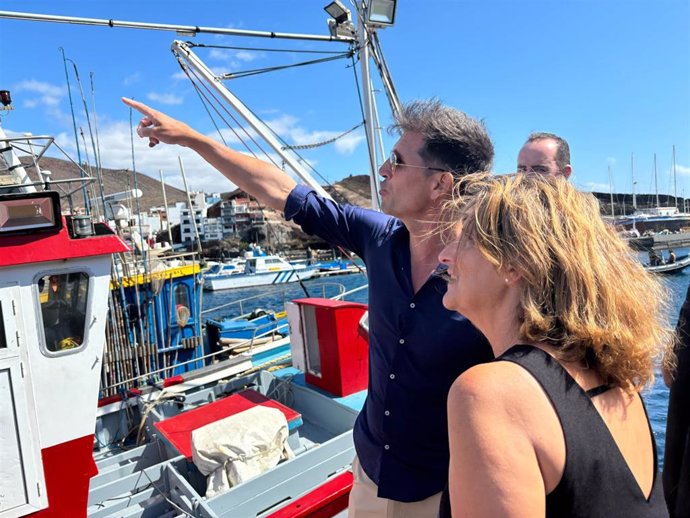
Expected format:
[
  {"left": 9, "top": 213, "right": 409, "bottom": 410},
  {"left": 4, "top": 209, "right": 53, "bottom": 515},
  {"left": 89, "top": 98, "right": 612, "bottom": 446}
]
[{"left": 203, "top": 266, "right": 690, "bottom": 463}]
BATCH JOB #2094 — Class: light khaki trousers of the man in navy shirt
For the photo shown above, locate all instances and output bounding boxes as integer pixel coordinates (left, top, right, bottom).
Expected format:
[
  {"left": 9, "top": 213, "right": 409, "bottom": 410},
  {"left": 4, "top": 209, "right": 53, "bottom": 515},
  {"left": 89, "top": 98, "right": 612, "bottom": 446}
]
[{"left": 347, "top": 457, "right": 441, "bottom": 518}]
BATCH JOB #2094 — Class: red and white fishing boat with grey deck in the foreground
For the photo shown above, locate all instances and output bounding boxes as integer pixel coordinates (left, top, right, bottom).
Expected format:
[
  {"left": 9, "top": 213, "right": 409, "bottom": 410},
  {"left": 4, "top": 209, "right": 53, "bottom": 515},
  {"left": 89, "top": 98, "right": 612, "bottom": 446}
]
[{"left": 0, "top": 183, "right": 367, "bottom": 517}]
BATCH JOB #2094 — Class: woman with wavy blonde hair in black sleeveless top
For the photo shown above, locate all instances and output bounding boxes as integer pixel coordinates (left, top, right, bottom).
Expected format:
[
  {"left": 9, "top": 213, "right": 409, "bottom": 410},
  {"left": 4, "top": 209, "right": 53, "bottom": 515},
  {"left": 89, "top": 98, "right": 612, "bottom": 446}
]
[{"left": 439, "top": 174, "right": 671, "bottom": 518}]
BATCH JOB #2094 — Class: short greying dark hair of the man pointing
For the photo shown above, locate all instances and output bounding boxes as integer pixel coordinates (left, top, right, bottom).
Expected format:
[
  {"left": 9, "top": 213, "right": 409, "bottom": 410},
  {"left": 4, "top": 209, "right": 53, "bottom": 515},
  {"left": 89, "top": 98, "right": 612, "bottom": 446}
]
[{"left": 391, "top": 99, "right": 494, "bottom": 176}]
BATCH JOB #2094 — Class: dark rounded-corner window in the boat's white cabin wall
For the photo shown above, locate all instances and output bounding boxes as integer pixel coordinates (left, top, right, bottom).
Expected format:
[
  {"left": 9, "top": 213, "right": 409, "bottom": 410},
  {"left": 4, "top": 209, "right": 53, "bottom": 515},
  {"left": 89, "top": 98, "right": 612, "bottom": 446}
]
[{"left": 37, "top": 272, "right": 89, "bottom": 352}]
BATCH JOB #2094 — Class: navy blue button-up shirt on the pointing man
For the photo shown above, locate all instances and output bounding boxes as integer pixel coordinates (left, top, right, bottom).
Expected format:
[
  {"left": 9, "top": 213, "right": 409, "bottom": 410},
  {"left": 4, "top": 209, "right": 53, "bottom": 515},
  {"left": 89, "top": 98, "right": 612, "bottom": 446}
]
[{"left": 285, "top": 186, "right": 493, "bottom": 502}]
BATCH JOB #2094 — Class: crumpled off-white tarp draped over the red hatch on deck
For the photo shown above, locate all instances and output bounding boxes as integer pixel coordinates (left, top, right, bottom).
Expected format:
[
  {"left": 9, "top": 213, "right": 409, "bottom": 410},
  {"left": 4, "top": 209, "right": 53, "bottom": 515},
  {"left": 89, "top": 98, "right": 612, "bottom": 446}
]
[{"left": 192, "top": 405, "right": 294, "bottom": 498}]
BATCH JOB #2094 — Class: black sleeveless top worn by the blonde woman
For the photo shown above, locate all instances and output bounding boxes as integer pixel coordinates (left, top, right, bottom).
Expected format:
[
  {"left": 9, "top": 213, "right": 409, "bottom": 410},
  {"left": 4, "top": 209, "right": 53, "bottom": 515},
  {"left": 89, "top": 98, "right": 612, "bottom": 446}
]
[{"left": 439, "top": 345, "right": 668, "bottom": 518}]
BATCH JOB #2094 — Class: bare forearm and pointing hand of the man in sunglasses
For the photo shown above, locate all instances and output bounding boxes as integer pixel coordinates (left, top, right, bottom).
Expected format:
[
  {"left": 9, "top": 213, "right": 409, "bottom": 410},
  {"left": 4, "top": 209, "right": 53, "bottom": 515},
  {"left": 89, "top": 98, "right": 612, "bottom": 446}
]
[{"left": 122, "top": 97, "right": 297, "bottom": 211}]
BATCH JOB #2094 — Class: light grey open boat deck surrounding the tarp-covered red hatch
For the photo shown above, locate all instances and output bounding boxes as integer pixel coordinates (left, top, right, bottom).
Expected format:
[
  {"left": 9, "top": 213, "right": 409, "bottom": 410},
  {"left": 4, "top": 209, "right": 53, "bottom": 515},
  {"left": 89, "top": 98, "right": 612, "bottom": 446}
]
[{"left": 88, "top": 367, "right": 366, "bottom": 518}]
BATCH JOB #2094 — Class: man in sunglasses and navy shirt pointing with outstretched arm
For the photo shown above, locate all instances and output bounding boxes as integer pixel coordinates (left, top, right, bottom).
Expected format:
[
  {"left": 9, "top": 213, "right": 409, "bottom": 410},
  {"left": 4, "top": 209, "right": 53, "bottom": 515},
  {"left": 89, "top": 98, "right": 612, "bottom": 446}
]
[{"left": 124, "top": 99, "right": 493, "bottom": 518}]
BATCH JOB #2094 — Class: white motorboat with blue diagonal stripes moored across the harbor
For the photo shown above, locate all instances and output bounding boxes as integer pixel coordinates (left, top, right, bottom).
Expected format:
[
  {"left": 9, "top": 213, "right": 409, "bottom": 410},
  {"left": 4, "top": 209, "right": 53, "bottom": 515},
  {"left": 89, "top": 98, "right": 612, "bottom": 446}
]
[{"left": 204, "top": 255, "right": 318, "bottom": 291}]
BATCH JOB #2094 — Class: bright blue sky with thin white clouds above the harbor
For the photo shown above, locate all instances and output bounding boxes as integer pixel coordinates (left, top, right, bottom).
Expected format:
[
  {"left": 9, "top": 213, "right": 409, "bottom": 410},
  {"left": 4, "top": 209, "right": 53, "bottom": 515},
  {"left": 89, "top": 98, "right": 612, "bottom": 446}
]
[{"left": 0, "top": 0, "right": 690, "bottom": 200}]
